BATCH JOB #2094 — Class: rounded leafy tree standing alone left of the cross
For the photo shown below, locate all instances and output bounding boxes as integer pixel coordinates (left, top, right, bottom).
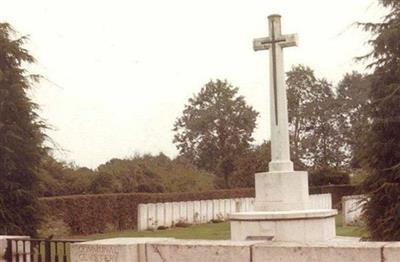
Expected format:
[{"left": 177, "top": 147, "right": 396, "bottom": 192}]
[{"left": 173, "top": 80, "right": 258, "bottom": 188}]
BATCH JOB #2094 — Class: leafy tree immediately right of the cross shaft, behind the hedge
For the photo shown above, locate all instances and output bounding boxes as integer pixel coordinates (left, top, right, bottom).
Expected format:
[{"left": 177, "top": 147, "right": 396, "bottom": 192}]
[{"left": 286, "top": 65, "right": 344, "bottom": 169}]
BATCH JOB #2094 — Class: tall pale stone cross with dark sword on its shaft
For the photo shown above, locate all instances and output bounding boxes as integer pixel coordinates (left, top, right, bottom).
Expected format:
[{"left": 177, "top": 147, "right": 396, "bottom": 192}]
[{"left": 253, "top": 15, "right": 297, "bottom": 172}]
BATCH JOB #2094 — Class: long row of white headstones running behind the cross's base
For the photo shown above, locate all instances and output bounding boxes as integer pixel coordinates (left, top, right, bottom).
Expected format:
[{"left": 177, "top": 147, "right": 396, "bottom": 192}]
[{"left": 137, "top": 194, "right": 332, "bottom": 231}]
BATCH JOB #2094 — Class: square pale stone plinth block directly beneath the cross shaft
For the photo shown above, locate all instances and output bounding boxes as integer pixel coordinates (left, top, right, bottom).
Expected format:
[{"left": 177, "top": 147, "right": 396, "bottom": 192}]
[{"left": 255, "top": 171, "right": 309, "bottom": 211}]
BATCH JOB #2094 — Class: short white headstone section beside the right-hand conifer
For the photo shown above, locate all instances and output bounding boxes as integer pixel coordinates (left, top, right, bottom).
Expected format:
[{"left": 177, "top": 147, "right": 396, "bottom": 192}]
[{"left": 342, "top": 195, "right": 365, "bottom": 226}]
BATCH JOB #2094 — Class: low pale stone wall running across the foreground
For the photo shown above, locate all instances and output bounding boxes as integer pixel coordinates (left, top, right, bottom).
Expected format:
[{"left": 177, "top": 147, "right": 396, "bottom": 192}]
[{"left": 71, "top": 238, "right": 400, "bottom": 262}]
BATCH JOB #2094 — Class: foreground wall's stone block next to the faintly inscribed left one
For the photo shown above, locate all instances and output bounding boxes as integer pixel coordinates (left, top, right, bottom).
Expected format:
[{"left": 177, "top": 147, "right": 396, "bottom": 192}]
[{"left": 146, "top": 240, "right": 261, "bottom": 262}]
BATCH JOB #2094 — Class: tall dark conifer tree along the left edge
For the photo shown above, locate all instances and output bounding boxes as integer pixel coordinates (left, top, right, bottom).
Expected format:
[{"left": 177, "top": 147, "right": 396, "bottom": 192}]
[{"left": 0, "top": 23, "right": 45, "bottom": 235}]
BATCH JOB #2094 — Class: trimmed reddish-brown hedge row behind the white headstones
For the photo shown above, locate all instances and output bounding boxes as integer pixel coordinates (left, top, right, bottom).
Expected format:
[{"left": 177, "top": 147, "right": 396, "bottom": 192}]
[{"left": 40, "top": 185, "right": 355, "bottom": 235}]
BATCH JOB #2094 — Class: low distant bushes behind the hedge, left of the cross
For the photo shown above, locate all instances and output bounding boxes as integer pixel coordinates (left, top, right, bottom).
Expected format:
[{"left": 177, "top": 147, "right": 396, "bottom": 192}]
[{"left": 37, "top": 143, "right": 270, "bottom": 197}]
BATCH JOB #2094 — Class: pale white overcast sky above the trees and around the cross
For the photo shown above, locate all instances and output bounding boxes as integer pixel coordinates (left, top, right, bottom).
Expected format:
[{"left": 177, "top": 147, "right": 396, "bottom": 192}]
[{"left": 1, "top": 0, "right": 384, "bottom": 168}]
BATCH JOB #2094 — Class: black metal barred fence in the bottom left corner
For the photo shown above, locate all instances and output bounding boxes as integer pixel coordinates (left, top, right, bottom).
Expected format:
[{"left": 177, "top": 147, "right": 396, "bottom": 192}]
[{"left": 5, "top": 238, "right": 84, "bottom": 262}]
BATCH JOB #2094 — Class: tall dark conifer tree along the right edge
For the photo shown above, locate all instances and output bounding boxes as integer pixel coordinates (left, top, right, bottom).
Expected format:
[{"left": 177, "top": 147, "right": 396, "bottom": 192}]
[{"left": 363, "top": 0, "right": 400, "bottom": 241}]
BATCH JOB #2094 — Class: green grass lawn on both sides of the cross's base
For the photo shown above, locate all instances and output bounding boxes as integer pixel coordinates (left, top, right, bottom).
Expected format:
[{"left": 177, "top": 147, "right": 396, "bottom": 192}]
[{"left": 84, "top": 214, "right": 364, "bottom": 240}]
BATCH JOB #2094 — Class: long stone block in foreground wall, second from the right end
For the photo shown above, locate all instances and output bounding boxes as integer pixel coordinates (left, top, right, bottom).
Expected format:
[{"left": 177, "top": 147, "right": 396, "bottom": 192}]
[{"left": 252, "top": 241, "right": 386, "bottom": 262}]
